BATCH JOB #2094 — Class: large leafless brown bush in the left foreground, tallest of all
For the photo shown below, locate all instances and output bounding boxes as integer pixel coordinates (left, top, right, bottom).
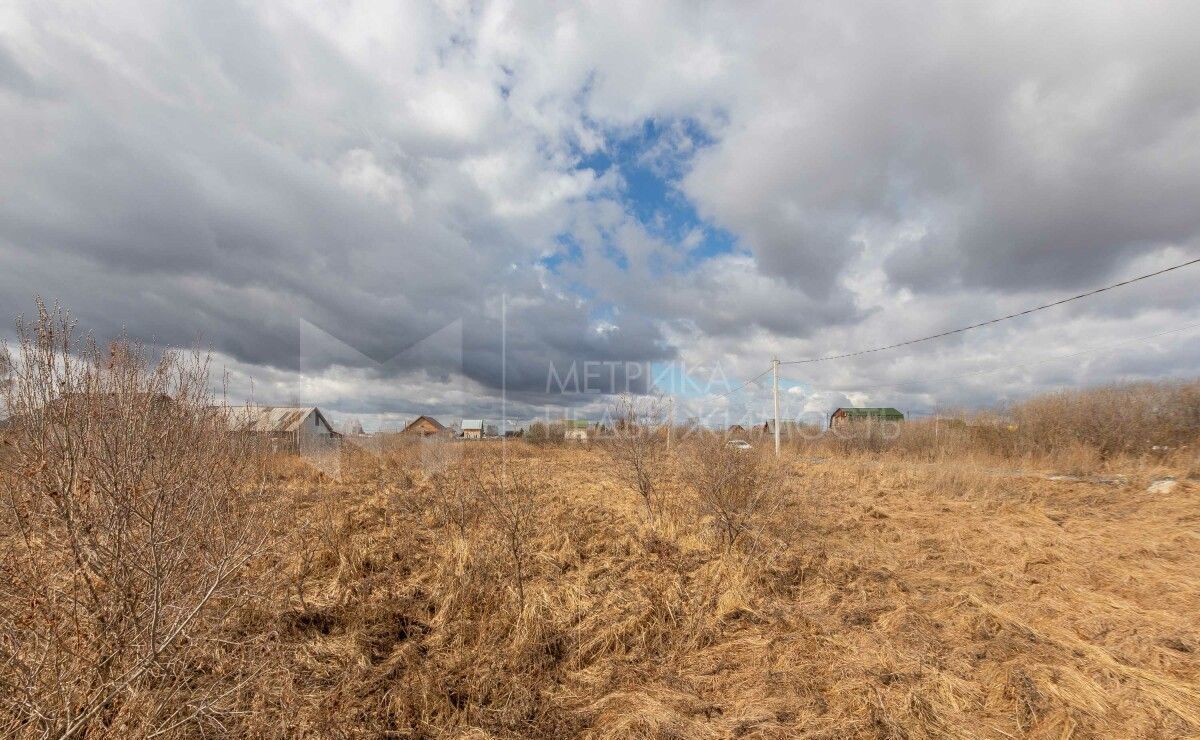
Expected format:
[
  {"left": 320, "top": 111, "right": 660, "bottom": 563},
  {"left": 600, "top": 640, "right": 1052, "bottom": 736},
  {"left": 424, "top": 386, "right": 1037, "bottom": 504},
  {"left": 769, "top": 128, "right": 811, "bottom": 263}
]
[{"left": 0, "top": 302, "right": 260, "bottom": 738}]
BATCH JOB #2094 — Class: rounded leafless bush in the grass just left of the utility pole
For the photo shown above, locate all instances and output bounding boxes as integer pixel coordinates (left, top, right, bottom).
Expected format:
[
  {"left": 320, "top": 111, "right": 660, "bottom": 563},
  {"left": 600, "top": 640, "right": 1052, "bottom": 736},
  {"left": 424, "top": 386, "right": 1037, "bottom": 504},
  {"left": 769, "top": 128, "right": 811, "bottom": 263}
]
[{"left": 682, "top": 434, "right": 784, "bottom": 551}]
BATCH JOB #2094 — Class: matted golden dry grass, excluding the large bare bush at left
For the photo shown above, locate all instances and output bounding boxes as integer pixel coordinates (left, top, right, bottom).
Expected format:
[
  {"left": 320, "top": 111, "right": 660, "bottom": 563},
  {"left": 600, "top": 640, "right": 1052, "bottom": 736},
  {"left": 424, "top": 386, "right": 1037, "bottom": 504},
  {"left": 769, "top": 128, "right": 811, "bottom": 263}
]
[{"left": 232, "top": 445, "right": 1200, "bottom": 738}]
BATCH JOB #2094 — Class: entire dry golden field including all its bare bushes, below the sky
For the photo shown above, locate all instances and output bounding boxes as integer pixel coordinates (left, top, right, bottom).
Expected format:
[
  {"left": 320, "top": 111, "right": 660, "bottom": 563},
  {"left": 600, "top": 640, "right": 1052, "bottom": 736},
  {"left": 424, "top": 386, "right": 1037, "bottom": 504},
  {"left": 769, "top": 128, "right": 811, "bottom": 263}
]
[{"left": 0, "top": 309, "right": 1200, "bottom": 739}]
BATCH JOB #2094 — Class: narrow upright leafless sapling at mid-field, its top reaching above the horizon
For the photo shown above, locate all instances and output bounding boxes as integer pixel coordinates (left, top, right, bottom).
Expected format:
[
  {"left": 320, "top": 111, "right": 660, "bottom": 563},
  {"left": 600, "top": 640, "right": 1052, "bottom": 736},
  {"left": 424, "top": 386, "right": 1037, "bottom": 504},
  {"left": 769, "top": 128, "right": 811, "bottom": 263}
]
[{"left": 605, "top": 393, "right": 667, "bottom": 518}]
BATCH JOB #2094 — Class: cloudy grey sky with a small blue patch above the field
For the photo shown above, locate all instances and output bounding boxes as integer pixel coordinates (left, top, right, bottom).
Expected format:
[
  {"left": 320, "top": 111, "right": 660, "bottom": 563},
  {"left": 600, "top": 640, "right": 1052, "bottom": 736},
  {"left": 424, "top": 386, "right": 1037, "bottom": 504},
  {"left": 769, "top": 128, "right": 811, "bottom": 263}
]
[{"left": 0, "top": 0, "right": 1200, "bottom": 428}]
